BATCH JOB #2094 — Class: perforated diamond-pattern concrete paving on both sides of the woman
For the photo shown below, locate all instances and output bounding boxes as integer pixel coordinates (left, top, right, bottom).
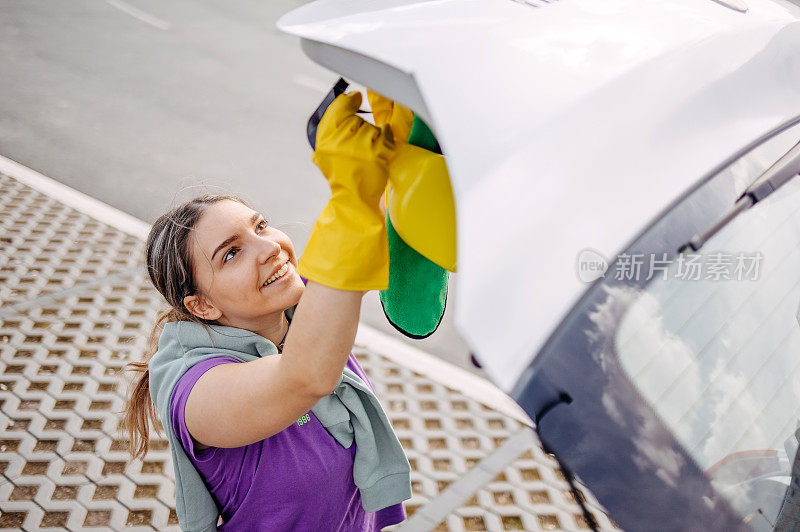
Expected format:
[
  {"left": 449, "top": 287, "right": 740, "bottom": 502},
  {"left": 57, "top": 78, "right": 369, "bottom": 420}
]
[{"left": 0, "top": 174, "right": 614, "bottom": 531}]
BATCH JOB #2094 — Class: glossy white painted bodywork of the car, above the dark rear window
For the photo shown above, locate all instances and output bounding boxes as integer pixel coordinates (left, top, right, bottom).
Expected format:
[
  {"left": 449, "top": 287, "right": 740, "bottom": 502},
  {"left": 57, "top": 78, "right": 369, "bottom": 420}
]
[{"left": 279, "top": 0, "right": 800, "bottom": 391}]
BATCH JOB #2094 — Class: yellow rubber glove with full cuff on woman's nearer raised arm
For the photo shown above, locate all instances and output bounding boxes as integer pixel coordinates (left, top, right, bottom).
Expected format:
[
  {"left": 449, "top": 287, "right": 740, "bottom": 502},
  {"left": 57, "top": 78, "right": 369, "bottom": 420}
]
[{"left": 297, "top": 92, "right": 395, "bottom": 291}]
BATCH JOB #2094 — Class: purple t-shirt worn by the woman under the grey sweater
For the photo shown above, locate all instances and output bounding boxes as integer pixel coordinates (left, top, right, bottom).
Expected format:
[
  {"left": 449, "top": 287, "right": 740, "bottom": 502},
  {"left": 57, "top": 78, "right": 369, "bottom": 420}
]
[{"left": 171, "top": 354, "right": 405, "bottom": 532}]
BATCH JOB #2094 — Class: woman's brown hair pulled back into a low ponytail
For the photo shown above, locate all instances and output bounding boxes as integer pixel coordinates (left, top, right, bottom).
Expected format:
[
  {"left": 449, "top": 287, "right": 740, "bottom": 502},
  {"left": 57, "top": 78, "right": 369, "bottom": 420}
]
[{"left": 123, "top": 194, "right": 249, "bottom": 458}]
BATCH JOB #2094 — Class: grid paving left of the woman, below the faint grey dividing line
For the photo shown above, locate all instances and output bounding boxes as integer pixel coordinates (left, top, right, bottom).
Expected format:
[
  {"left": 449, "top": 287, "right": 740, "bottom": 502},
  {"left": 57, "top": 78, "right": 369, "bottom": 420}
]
[{"left": 0, "top": 277, "right": 177, "bottom": 530}]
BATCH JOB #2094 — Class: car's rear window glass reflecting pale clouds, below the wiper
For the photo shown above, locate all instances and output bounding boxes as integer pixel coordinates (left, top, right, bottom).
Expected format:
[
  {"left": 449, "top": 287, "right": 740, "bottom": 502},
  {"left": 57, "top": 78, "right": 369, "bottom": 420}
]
[{"left": 614, "top": 180, "right": 800, "bottom": 530}]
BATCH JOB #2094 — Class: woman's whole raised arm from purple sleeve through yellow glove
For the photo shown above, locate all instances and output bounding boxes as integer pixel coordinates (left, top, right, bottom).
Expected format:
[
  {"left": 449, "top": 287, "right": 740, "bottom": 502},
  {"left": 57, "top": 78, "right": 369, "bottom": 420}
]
[{"left": 185, "top": 93, "right": 394, "bottom": 447}]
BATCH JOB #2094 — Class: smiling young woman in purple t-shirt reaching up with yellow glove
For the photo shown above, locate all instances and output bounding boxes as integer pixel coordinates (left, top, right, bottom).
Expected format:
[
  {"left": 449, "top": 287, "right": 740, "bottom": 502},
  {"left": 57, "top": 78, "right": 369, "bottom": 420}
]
[{"left": 126, "top": 93, "right": 410, "bottom": 531}]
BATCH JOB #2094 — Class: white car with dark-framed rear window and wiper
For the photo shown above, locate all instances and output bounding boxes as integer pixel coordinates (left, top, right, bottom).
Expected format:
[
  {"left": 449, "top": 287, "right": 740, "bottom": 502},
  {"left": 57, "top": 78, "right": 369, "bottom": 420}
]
[{"left": 278, "top": 0, "right": 800, "bottom": 530}]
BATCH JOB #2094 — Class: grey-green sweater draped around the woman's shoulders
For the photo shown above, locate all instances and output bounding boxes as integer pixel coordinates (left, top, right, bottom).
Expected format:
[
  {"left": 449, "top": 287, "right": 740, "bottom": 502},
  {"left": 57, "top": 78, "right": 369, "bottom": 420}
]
[{"left": 149, "top": 321, "right": 411, "bottom": 532}]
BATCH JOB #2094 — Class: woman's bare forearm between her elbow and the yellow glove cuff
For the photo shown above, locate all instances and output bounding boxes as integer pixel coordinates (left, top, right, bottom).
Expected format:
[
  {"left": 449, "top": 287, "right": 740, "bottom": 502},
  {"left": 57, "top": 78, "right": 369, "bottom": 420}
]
[{"left": 281, "top": 280, "right": 364, "bottom": 396}]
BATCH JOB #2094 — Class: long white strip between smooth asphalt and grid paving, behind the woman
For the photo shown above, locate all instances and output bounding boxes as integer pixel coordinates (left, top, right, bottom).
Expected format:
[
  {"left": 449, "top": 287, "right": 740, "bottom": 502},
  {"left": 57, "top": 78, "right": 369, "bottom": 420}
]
[{"left": 0, "top": 155, "right": 533, "bottom": 420}]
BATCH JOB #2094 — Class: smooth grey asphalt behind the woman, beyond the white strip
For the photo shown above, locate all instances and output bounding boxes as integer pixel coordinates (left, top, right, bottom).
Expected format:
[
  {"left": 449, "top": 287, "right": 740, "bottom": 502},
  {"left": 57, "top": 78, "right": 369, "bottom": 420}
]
[{"left": 0, "top": 0, "right": 477, "bottom": 372}]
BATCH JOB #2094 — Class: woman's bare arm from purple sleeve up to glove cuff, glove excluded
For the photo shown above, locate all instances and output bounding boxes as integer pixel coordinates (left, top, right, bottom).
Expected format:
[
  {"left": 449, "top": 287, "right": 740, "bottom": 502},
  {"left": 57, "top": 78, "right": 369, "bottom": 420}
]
[{"left": 185, "top": 281, "right": 363, "bottom": 447}]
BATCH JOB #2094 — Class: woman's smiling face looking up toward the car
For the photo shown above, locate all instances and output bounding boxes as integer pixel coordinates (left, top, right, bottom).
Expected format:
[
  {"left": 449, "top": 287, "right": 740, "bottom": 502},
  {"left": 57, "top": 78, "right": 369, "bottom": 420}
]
[{"left": 184, "top": 200, "right": 304, "bottom": 332}]
